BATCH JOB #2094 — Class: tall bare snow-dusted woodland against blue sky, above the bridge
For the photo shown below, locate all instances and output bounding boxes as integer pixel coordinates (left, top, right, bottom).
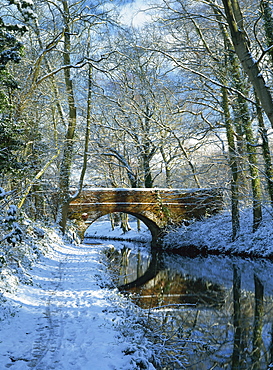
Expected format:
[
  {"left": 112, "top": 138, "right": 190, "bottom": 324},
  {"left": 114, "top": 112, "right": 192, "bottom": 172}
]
[{"left": 0, "top": 0, "right": 273, "bottom": 244}]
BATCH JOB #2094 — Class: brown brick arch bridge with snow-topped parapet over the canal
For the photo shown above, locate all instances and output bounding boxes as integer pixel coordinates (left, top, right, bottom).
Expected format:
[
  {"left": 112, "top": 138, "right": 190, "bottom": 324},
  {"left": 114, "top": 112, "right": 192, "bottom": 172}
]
[{"left": 68, "top": 188, "right": 223, "bottom": 241}]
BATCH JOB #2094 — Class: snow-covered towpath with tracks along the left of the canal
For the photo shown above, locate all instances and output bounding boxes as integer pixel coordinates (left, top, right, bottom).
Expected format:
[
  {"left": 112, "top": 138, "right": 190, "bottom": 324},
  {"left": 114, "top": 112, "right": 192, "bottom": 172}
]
[{"left": 0, "top": 236, "right": 154, "bottom": 370}]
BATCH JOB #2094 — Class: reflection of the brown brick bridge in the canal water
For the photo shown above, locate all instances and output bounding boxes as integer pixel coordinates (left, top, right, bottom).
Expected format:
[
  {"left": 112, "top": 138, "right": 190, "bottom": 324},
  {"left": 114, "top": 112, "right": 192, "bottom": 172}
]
[{"left": 109, "top": 248, "right": 226, "bottom": 309}]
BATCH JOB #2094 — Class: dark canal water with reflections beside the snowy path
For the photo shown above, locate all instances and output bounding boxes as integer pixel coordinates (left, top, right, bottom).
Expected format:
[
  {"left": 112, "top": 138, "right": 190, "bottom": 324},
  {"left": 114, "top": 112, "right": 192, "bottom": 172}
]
[{"left": 84, "top": 238, "right": 273, "bottom": 370}]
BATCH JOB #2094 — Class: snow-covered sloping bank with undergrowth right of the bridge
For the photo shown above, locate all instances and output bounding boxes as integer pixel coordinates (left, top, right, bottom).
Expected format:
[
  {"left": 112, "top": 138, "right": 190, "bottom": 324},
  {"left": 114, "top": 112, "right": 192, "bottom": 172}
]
[{"left": 163, "top": 209, "right": 273, "bottom": 258}]
